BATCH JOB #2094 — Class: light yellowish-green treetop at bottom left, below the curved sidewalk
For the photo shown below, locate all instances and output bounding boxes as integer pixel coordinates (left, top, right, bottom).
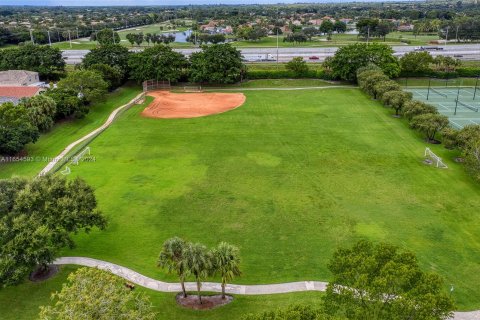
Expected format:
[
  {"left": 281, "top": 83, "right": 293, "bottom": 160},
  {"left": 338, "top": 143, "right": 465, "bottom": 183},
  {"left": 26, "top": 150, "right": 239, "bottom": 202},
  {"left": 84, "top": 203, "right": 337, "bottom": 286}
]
[{"left": 39, "top": 268, "right": 157, "bottom": 320}]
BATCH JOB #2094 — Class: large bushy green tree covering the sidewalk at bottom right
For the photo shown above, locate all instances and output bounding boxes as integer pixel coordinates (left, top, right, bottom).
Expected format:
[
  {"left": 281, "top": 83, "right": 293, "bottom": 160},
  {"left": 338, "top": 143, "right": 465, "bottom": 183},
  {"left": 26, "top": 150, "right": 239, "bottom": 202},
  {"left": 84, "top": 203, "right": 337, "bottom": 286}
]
[{"left": 325, "top": 241, "right": 454, "bottom": 320}]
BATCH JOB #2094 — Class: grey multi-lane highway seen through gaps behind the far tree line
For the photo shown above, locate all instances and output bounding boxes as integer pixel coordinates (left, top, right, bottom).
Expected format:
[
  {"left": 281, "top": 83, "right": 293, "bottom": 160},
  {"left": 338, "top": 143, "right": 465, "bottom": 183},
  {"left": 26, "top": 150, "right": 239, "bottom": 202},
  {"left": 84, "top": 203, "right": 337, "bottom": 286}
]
[{"left": 63, "top": 44, "right": 480, "bottom": 64}]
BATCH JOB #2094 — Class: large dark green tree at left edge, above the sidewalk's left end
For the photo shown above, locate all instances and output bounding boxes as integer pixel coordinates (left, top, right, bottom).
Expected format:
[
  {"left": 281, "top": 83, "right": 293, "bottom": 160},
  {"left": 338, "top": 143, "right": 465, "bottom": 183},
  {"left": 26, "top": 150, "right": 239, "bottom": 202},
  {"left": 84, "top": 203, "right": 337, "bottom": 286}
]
[{"left": 0, "top": 176, "right": 106, "bottom": 286}]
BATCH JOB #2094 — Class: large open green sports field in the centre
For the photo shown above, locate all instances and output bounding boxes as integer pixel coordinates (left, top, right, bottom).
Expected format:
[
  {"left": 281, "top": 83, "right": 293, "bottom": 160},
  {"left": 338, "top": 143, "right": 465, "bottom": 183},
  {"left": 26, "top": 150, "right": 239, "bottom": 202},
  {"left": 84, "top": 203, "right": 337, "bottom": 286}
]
[{"left": 37, "top": 89, "right": 480, "bottom": 309}]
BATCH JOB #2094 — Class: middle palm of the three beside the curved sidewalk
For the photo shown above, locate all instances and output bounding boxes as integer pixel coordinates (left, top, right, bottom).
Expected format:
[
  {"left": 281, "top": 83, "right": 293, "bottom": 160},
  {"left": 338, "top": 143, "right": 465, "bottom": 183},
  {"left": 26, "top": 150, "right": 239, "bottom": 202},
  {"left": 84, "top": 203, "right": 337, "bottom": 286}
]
[{"left": 184, "top": 243, "right": 212, "bottom": 304}]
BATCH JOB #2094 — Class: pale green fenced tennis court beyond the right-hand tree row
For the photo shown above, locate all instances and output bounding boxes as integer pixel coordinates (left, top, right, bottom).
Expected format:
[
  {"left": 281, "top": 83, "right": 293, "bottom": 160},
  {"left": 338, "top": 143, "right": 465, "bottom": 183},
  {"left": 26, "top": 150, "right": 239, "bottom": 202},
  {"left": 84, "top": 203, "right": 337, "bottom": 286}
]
[{"left": 405, "top": 86, "right": 480, "bottom": 129}]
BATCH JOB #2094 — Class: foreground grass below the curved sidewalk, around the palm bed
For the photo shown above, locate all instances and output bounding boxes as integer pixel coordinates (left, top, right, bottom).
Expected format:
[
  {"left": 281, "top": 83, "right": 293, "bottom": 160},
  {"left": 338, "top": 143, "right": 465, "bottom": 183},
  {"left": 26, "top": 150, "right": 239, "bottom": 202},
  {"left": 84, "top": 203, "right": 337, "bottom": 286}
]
[{"left": 0, "top": 266, "right": 322, "bottom": 320}]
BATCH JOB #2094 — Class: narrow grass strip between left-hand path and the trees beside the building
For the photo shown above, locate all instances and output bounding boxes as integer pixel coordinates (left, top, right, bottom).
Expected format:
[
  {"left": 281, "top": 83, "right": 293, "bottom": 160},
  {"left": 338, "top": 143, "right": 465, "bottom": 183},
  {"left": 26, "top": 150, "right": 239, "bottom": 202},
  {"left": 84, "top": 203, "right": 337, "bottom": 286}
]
[{"left": 0, "top": 86, "right": 141, "bottom": 178}]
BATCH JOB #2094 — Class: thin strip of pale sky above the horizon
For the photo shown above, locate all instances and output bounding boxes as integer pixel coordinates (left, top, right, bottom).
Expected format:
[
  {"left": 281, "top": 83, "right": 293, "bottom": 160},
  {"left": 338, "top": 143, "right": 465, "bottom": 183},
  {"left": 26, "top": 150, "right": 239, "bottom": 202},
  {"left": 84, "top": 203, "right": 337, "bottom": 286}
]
[{"left": 0, "top": 0, "right": 394, "bottom": 6}]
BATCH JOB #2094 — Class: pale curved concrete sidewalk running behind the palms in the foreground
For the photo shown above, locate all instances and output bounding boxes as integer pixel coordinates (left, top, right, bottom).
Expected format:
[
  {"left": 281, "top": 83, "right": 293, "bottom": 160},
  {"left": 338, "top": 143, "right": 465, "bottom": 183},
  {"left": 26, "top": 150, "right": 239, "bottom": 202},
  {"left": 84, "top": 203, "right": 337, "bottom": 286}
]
[{"left": 53, "top": 257, "right": 480, "bottom": 320}]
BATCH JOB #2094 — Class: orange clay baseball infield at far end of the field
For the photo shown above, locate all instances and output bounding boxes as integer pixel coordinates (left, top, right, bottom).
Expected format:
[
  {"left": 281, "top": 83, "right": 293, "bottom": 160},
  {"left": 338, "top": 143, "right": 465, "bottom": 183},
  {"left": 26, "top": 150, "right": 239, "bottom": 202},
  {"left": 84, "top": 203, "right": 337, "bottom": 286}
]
[{"left": 142, "top": 91, "right": 246, "bottom": 119}]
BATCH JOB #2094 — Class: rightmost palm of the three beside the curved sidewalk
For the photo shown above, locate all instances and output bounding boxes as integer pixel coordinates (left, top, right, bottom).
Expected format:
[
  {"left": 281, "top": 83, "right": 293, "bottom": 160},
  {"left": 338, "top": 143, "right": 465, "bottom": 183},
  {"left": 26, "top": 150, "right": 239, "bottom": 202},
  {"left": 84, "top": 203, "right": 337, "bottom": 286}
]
[{"left": 213, "top": 242, "right": 242, "bottom": 299}]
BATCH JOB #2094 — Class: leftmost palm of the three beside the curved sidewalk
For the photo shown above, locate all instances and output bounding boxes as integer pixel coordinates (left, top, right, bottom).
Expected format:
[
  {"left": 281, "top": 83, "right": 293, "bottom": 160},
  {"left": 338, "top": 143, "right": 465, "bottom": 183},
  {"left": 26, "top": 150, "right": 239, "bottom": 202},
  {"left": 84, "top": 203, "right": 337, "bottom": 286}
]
[{"left": 158, "top": 237, "right": 188, "bottom": 298}]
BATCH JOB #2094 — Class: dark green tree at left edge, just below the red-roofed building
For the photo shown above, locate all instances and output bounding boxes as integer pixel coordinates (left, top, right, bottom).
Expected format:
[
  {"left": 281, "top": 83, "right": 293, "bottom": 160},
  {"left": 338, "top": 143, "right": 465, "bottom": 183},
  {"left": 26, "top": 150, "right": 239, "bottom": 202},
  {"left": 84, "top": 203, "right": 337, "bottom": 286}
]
[{"left": 0, "top": 102, "right": 39, "bottom": 155}]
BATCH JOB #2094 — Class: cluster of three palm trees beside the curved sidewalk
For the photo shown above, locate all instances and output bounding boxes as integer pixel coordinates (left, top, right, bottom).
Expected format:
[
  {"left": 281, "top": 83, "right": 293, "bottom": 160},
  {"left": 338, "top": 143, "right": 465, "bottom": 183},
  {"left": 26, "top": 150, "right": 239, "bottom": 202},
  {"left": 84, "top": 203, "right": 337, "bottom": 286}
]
[{"left": 158, "top": 237, "right": 241, "bottom": 304}]
